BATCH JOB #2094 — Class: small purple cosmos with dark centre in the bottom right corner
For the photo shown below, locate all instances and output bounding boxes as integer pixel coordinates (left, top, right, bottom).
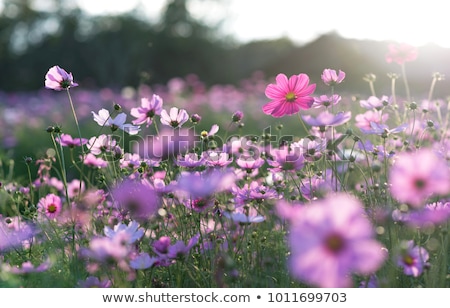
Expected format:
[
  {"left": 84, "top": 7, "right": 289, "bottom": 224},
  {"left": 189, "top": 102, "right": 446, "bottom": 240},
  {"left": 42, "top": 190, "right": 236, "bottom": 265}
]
[{"left": 397, "top": 241, "right": 429, "bottom": 277}]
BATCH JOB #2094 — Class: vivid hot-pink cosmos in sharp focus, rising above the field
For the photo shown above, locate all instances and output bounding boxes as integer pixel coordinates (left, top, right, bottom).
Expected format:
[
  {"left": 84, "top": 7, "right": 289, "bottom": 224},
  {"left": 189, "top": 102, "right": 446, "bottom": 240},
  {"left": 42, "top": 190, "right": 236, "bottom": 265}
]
[{"left": 262, "top": 74, "right": 316, "bottom": 118}]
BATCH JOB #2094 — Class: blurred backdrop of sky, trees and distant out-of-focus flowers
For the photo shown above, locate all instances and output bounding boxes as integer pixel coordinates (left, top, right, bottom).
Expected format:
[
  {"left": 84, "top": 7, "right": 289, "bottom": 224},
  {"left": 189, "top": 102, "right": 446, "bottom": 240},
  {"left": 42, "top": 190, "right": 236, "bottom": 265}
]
[{"left": 0, "top": 0, "right": 450, "bottom": 179}]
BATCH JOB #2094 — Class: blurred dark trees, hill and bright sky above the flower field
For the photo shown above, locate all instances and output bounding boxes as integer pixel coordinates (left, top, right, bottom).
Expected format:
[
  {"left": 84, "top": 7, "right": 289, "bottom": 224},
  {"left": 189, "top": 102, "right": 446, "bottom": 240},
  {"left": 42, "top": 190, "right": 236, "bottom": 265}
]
[{"left": 0, "top": 0, "right": 450, "bottom": 95}]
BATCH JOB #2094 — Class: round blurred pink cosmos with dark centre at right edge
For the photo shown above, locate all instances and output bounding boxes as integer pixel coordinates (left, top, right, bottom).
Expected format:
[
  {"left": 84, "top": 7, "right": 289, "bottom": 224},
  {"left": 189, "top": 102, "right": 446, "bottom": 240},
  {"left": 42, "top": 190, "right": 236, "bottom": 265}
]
[{"left": 389, "top": 148, "right": 450, "bottom": 208}]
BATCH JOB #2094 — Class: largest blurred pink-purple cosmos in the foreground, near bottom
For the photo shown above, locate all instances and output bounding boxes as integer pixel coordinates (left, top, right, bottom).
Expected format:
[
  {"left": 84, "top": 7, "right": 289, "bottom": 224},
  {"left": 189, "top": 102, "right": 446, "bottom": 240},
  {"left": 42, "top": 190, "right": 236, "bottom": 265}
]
[{"left": 280, "top": 193, "right": 386, "bottom": 288}]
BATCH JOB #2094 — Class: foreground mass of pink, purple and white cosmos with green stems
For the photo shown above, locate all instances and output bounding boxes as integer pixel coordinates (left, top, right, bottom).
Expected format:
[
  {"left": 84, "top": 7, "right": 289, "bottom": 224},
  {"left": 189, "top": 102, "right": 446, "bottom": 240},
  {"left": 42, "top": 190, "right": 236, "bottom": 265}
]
[{"left": 0, "top": 45, "right": 450, "bottom": 288}]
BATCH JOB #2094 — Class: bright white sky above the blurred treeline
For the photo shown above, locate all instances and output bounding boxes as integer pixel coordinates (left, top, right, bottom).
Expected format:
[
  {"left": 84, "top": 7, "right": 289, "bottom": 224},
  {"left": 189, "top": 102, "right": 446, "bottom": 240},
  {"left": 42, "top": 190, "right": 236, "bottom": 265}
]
[{"left": 78, "top": 0, "right": 450, "bottom": 48}]
